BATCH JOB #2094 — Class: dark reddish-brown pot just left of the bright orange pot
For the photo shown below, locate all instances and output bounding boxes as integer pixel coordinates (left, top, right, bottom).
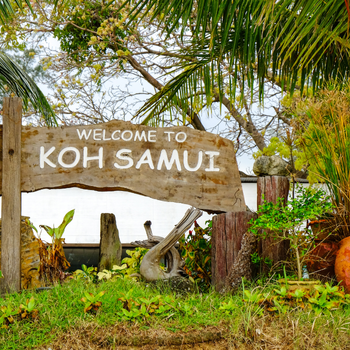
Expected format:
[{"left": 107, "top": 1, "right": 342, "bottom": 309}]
[{"left": 306, "top": 242, "right": 339, "bottom": 278}]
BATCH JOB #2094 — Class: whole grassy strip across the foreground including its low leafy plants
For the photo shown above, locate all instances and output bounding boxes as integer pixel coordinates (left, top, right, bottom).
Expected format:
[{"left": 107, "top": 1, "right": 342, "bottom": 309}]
[{"left": 0, "top": 278, "right": 350, "bottom": 350}]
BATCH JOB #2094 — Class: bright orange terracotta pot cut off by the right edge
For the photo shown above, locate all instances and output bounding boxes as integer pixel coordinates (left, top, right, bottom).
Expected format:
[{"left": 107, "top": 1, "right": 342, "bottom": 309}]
[{"left": 335, "top": 237, "right": 350, "bottom": 293}]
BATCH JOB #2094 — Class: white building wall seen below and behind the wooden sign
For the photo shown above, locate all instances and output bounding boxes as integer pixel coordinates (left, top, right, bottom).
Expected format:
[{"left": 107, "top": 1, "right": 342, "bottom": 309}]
[{"left": 0, "top": 183, "right": 257, "bottom": 243}]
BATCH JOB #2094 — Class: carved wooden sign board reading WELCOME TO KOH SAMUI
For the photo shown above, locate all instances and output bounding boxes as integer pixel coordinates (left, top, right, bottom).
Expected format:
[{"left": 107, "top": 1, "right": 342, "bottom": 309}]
[{"left": 0, "top": 121, "right": 245, "bottom": 212}]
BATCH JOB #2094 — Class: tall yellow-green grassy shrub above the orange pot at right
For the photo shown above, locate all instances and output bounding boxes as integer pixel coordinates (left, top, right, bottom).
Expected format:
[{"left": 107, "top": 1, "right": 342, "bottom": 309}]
[{"left": 296, "top": 83, "right": 350, "bottom": 238}]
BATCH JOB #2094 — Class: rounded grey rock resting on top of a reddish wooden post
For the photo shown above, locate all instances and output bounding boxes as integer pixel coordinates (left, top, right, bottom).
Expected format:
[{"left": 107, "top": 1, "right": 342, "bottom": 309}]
[{"left": 253, "top": 155, "right": 291, "bottom": 176}]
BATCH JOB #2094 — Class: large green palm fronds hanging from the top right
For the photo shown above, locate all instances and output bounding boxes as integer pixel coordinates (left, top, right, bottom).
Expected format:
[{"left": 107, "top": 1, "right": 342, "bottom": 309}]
[{"left": 126, "top": 0, "right": 350, "bottom": 125}]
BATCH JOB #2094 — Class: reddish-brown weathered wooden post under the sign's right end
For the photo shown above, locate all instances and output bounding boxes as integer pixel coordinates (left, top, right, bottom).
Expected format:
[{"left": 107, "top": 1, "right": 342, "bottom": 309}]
[{"left": 211, "top": 211, "right": 256, "bottom": 291}]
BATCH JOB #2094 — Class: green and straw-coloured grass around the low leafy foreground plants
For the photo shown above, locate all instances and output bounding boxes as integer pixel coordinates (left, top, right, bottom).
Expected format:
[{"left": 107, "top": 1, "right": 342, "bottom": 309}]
[{"left": 0, "top": 279, "right": 350, "bottom": 350}]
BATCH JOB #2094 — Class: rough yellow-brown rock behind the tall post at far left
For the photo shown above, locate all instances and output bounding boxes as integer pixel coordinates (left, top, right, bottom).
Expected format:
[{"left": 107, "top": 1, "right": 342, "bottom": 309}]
[{"left": 0, "top": 216, "right": 42, "bottom": 289}]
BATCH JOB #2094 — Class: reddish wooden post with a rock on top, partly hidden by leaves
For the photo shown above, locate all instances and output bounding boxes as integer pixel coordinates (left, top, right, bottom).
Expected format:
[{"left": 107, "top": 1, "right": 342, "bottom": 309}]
[{"left": 257, "top": 176, "right": 289, "bottom": 264}]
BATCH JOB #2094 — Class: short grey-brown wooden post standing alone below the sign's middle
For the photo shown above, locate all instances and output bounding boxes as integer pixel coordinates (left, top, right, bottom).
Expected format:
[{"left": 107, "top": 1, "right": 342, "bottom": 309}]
[{"left": 98, "top": 214, "right": 122, "bottom": 271}]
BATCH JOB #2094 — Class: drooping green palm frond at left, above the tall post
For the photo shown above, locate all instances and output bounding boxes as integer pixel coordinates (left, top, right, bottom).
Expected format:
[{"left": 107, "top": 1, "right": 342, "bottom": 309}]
[{"left": 0, "top": 52, "right": 57, "bottom": 126}]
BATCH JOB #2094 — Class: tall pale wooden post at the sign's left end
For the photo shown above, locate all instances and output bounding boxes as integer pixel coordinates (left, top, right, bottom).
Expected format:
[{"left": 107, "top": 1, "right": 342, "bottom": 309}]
[{"left": 1, "top": 97, "right": 22, "bottom": 292}]
